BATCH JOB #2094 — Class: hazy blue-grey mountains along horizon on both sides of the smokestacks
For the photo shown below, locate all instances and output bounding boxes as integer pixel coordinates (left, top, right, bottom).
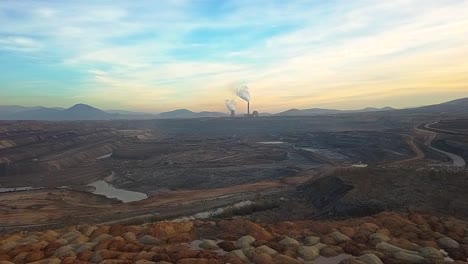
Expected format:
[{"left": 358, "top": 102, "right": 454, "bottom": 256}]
[{"left": 0, "top": 98, "right": 468, "bottom": 121}]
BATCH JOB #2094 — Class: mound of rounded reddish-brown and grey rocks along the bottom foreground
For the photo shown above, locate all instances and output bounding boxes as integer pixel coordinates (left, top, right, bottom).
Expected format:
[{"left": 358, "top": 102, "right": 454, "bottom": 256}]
[{"left": 0, "top": 213, "right": 468, "bottom": 264}]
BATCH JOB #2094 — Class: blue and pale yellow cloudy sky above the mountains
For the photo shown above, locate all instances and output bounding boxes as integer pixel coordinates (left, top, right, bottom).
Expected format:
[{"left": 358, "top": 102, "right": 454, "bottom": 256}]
[{"left": 0, "top": 0, "right": 468, "bottom": 113}]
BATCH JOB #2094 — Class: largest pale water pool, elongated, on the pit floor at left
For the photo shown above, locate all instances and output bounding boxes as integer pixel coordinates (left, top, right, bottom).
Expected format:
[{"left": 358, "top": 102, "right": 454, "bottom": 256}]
[{"left": 88, "top": 180, "right": 148, "bottom": 203}]
